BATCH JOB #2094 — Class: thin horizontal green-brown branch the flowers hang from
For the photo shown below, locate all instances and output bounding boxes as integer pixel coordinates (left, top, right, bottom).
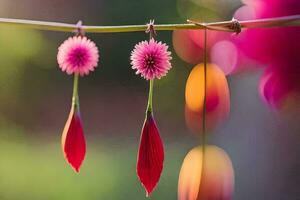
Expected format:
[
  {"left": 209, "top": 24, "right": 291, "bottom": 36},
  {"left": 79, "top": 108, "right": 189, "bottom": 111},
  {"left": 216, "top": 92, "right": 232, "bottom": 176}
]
[{"left": 0, "top": 15, "right": 300, "bottom": 33}]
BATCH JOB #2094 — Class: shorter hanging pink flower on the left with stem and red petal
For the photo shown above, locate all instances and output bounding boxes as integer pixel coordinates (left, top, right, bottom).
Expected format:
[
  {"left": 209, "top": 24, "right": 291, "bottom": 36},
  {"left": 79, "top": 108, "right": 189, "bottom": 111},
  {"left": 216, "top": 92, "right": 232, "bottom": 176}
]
[{"left": 57, "top": 22, "right": 99, "bottom": 172}]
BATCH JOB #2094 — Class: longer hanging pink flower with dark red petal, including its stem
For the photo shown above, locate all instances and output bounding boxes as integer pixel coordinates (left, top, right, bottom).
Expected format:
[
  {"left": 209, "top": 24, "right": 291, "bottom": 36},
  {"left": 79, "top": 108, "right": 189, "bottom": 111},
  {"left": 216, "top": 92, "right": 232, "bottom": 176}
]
[{"left": 130, "top": 21, "right": 172, "bottom": 197}]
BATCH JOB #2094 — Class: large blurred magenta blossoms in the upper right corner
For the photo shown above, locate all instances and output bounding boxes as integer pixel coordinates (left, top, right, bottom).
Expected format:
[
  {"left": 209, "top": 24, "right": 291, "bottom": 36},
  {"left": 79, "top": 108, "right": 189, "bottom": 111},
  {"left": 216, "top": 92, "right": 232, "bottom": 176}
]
[{"left": 236, "top": 0, "right": 300, "bottom": 109}]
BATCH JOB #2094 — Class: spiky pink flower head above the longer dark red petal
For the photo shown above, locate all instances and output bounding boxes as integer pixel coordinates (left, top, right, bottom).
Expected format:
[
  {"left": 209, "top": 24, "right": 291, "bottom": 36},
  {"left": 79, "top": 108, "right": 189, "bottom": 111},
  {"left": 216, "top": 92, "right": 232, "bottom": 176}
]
[{"left": 130, "top": 38, "right": 172, "bottom": 80}]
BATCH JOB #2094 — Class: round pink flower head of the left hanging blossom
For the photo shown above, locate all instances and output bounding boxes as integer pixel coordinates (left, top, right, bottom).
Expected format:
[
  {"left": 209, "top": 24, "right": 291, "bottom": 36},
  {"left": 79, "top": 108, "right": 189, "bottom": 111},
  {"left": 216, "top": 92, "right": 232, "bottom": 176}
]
[{"left": 57, "top": 36, "right": 99, "bottom": 76}]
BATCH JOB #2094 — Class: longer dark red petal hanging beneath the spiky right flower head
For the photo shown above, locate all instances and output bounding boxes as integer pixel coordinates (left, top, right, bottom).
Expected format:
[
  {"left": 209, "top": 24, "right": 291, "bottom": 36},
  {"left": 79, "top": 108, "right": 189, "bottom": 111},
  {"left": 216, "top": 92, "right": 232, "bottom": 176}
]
[{"left": 137, "top": 114, "right": 164, "bottom": 197}]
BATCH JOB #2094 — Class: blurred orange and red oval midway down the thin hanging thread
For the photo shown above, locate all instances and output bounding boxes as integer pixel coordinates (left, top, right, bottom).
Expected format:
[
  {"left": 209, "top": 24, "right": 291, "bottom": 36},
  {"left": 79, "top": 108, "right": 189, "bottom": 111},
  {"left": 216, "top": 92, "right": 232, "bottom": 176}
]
[{"left": 185, "top": 64, "right": 230, "bottom": 132}]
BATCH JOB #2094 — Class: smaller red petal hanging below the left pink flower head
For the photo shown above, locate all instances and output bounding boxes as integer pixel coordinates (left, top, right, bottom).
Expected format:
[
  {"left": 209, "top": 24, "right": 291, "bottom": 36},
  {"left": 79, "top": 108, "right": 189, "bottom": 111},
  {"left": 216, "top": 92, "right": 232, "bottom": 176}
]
[{"left": 62, "top": 108, "right": 86, "bottom": 172}]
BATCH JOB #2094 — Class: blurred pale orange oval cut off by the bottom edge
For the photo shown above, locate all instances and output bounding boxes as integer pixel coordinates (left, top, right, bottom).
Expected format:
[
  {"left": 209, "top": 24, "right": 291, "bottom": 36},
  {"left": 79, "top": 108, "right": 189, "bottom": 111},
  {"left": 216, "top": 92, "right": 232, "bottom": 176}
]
[{"left": 178, "top": 145, "right": 234, "bottom": 200}]
